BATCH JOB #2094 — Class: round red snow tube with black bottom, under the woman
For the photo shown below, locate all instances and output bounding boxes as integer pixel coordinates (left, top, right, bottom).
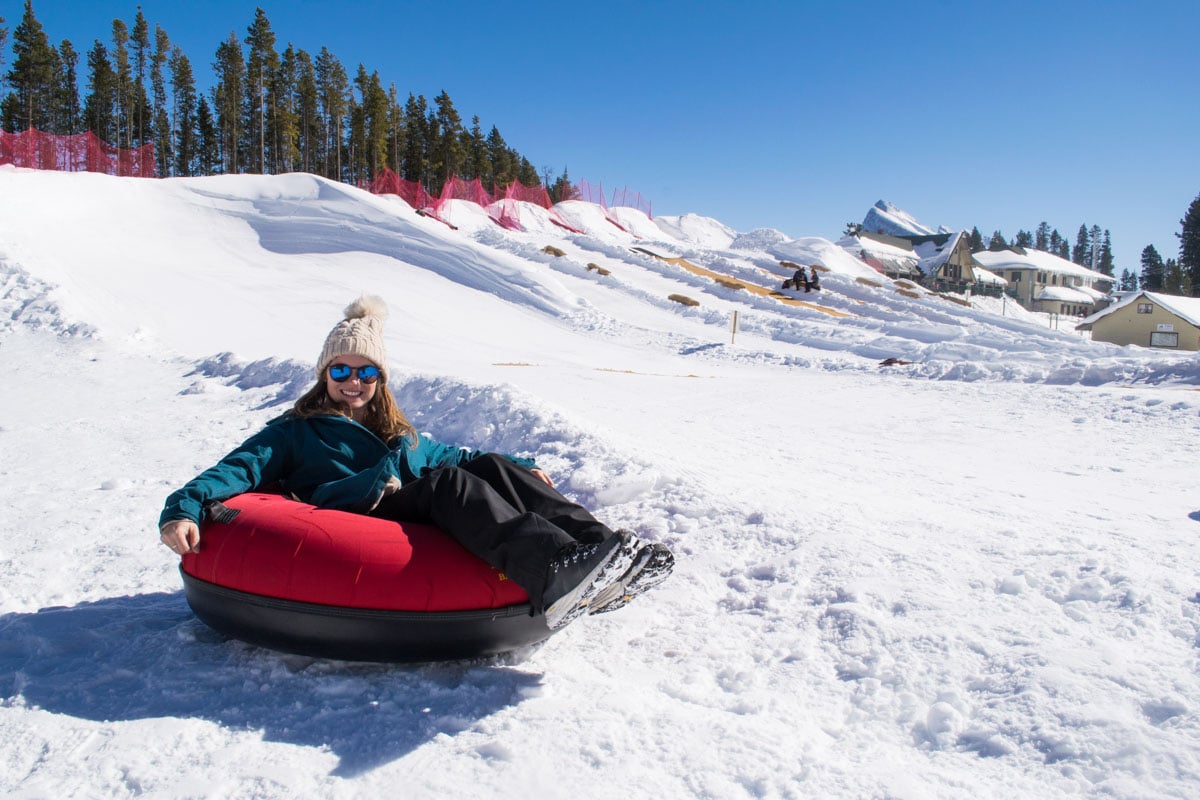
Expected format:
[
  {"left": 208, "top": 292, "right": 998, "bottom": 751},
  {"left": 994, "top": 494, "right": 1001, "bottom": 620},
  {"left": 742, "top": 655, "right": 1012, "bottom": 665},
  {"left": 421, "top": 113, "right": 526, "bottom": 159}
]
[{"left": 180, "top": 494, "right": 551, "bottom": 661}]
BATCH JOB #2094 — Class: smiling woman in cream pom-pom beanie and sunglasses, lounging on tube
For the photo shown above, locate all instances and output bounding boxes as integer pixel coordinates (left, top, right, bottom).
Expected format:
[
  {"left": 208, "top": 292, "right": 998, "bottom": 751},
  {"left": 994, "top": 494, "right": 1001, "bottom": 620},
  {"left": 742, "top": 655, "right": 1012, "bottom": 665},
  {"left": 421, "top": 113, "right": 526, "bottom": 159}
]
[{"left": 158, "top": 296, "right": 674, "bottom": 630}]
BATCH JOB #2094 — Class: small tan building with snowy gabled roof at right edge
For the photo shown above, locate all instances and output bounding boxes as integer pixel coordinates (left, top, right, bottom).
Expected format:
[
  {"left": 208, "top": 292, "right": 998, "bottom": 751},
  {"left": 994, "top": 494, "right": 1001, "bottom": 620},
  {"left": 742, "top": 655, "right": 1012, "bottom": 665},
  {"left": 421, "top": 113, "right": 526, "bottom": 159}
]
[{"left": 1075, "top": 291, "right": 1200, "bottom": 350}]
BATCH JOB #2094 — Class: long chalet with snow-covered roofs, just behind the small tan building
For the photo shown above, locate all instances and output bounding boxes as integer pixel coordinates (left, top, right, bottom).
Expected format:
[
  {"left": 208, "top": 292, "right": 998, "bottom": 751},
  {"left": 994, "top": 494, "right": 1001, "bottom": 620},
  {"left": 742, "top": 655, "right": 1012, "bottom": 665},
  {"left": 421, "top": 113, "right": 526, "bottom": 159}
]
[{"left": 973, "top": 247, "right": 1112, "bottom": 317}]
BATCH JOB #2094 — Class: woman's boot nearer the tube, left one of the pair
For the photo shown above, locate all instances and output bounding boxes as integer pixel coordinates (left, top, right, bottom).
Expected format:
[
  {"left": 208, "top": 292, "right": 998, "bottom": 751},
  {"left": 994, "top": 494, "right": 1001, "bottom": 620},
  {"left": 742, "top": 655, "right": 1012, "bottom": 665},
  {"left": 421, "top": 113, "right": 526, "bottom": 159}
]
[{"left": 542, "top": 531, "right": 641, "bottom": 631}]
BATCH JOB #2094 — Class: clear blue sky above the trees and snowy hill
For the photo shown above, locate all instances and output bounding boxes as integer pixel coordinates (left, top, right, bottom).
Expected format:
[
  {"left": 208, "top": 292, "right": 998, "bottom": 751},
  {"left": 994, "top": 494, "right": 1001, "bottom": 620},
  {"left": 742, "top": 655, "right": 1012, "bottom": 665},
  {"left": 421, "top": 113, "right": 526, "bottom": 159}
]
[{"left": 9, "top": 0, "right": 1200, "bottom": 271}]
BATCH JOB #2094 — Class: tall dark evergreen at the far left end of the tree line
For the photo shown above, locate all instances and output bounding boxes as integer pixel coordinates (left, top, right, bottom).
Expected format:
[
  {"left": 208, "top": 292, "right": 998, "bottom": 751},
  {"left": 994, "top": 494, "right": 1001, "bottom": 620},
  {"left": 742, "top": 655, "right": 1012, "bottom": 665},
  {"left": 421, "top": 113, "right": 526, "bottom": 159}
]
[{"left": 0, "top": 0, "right": 62, "bottom": 133}]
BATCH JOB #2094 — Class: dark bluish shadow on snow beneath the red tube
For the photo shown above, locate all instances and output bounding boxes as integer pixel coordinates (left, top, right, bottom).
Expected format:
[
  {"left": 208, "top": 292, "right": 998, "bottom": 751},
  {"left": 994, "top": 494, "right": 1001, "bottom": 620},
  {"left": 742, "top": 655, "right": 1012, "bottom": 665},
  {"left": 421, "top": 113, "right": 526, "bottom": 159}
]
[{"left": 0, "top": 591, "right": 541, "bottom": 777}]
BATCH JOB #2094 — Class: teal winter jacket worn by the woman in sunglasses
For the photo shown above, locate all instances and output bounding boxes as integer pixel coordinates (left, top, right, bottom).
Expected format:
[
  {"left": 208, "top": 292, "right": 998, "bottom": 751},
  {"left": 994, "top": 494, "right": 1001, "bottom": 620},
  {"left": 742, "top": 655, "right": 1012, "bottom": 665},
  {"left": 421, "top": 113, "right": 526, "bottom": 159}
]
[{"left": 158, "top": 413, "right": 535, "bottom": 527}]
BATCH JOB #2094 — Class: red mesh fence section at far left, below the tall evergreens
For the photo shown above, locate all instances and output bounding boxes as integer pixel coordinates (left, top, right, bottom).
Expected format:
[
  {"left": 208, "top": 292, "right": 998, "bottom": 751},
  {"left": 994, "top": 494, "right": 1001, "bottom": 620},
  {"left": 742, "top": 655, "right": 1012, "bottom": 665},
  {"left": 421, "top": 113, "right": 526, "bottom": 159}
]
[{"left": 0, "top": 128, "right": 158, "bottom": 178}]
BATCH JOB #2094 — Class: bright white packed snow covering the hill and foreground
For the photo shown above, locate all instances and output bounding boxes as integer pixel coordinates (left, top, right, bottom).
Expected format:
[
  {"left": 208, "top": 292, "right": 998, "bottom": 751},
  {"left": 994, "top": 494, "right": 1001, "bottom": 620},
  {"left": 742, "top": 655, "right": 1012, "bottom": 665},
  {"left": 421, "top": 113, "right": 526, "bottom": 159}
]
[{"left": 0, "top": 168, "right": 1200, "bottom": 800}]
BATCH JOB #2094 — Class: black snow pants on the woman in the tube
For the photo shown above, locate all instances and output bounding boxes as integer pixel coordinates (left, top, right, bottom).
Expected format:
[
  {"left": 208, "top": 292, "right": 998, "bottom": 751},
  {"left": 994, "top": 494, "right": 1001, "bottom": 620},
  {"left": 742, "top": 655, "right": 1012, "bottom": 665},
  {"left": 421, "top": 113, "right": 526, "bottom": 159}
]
[{"left": 371, "top": 453, "right": 616, "bottom": 613}]
